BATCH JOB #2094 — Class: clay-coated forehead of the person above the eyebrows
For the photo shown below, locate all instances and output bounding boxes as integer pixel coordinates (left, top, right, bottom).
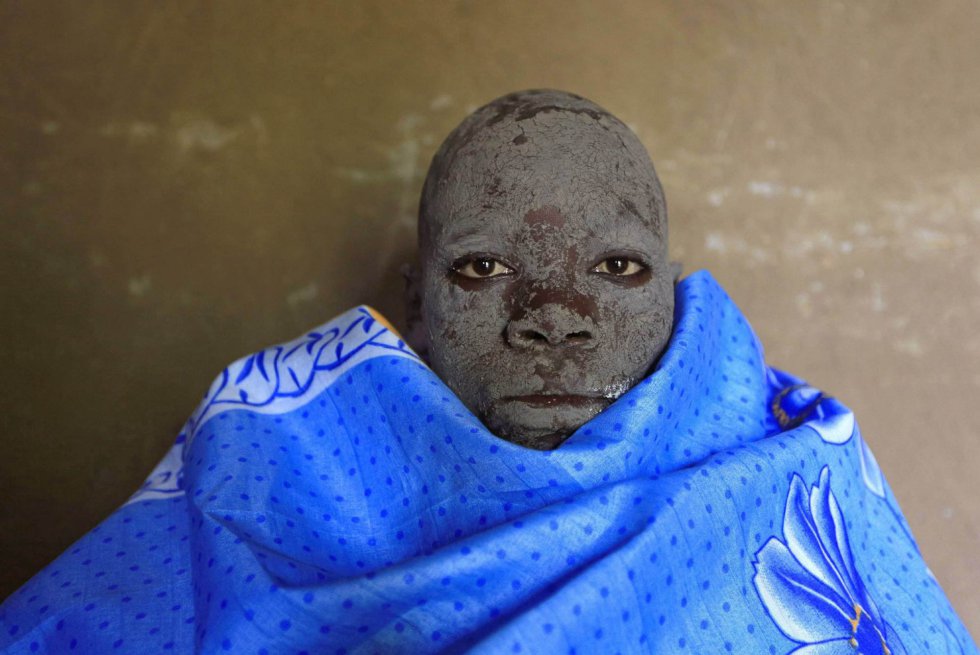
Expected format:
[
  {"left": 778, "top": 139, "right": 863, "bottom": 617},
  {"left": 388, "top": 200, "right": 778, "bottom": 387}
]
[{"left": 422, "top": 111, "right": 666, "bottom": 246}]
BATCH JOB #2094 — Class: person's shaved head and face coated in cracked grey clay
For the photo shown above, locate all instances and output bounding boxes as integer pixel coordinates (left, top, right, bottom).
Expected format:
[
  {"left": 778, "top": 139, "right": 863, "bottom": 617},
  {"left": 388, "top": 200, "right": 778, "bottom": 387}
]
[{"left": 408, "top": 91, "right": 675, "bottom": 449}]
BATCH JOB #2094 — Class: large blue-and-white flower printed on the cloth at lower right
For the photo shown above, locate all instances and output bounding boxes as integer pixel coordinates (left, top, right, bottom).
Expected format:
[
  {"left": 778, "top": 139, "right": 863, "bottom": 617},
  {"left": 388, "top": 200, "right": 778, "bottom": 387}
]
[{"left": 754, "top": 466, "right": 906, "bottom": 655}]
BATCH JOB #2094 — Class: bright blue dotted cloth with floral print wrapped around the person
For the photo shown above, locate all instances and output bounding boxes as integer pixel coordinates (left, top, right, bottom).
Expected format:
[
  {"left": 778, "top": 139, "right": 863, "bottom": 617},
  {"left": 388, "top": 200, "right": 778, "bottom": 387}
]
[{"left": 0, "top": 273, "right": 977, "bottom": 655}]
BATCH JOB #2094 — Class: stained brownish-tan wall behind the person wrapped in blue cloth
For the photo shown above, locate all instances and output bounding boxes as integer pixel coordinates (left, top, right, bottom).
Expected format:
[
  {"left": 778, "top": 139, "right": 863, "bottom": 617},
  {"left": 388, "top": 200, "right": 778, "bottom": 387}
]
[{"left": 0, "top": 0, "right": 980, "bottom": 635}]
